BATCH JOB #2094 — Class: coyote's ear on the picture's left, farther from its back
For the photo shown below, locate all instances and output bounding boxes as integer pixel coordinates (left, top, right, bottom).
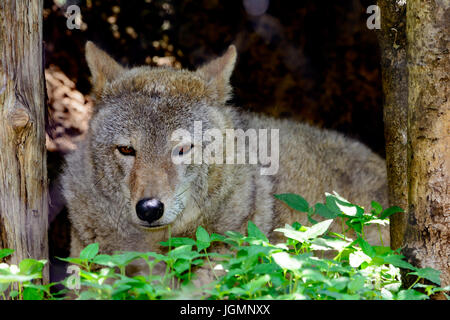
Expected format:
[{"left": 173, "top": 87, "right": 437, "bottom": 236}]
[{"left": 86, "top": 41, "right": 124, "bottom": 97}]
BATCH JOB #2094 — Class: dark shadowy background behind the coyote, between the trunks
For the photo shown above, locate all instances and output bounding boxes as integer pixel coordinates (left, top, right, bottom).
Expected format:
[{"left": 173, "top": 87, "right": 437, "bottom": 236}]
[{"left": 44, "top": 0, "right": 384, "bottom": 278}]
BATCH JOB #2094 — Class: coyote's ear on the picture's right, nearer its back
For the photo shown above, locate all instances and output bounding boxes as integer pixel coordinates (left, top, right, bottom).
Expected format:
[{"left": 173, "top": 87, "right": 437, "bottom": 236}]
[{"left": 197, "top": 45, "right": 237, "bottom": 103}]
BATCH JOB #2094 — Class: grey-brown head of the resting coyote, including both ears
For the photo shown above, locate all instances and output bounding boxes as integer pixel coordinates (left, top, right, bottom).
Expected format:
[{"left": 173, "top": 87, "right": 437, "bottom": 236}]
[{"left": 86, "top": 42, "right": 236, "bottom": 234}]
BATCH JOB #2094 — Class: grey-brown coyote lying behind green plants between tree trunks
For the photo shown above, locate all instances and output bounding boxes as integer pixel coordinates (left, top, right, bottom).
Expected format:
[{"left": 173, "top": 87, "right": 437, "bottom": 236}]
[{"left": 63, "top": 42, "right": 389, "bottom": 264}]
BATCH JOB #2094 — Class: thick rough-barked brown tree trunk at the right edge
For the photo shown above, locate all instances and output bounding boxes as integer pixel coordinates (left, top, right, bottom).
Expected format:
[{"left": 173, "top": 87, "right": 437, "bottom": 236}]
[{"left": 402, "top": 0, "right": 450, "bottom": 286}]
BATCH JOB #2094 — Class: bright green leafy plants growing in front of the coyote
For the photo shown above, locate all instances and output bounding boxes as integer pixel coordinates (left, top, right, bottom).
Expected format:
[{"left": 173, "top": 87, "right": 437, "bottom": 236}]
[{"left": 0, "top": 194, "right": 450, "bottom": 300}]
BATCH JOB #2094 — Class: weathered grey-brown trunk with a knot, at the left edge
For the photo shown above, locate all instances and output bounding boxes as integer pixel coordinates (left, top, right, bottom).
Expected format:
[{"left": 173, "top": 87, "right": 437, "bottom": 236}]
[{"left": 0, "top": 0, "right": 48, "bottom": 282}]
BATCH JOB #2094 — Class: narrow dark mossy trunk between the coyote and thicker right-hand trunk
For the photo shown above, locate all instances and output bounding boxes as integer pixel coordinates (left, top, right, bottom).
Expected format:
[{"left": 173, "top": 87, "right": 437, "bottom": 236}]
[{"left": 378, "top": 0, "right": 408, "bottom": 249}]
